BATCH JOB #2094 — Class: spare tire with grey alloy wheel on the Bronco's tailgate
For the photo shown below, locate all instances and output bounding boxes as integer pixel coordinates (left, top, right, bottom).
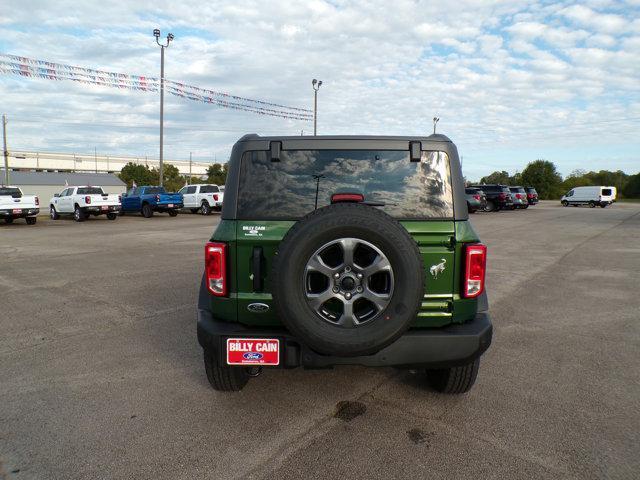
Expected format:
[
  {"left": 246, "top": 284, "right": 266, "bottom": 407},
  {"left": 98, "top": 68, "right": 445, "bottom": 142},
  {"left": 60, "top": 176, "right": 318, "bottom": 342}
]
[{"left": 270, "top": 203, "right": 425, "bottom": 356}]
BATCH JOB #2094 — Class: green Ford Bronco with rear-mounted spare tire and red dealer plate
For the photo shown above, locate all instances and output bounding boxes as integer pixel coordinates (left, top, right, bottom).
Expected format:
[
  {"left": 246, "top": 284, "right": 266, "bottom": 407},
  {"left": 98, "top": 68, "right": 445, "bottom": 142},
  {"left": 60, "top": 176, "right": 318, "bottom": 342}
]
[{"left": 198, "top": 135, "right": 492, "bottom": 393}]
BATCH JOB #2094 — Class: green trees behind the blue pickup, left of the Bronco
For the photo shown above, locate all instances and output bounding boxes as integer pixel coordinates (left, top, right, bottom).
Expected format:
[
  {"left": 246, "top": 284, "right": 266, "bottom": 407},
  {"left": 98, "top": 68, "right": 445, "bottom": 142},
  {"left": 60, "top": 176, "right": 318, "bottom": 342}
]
[{"left": 118, "top": 162, "right": 228, "bottom": 192}]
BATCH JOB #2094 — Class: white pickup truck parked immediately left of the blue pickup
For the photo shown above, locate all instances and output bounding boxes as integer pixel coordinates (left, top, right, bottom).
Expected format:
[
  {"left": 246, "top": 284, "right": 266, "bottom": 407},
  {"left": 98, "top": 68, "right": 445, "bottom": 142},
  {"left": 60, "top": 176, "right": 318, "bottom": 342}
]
[{"left": 49, "top": 186, "right": 121, "bottom": 222}]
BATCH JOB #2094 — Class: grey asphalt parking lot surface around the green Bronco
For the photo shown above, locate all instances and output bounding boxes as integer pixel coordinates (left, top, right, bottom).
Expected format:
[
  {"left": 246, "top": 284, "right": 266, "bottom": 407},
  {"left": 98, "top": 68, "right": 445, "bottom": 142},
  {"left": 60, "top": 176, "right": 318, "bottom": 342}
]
[{"left": 0, "top": 203, "right": 640, "bottom": 480}]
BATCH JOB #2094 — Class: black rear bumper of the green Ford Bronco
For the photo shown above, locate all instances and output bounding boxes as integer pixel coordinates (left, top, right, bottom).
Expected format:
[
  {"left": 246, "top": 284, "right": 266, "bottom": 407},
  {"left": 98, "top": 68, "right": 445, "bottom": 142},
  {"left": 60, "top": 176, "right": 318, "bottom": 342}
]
[{"left": 198, "top": 310, "right": 493, "bottom": 368}]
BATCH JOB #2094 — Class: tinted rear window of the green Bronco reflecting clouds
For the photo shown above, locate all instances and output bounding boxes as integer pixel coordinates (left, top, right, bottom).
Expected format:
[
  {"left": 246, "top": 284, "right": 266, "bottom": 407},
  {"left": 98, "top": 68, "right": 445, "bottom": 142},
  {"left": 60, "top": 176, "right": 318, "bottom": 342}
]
[{"left": 237, "top": 150, "right": 453, "bottom": 220}]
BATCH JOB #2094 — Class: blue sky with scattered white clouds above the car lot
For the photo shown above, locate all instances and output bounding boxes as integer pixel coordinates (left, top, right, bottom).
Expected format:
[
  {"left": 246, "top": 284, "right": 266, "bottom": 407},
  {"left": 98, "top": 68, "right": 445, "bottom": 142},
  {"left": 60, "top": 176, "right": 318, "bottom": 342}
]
[{"left": 0, "top": 0, "right": 640, "bottom": 179}]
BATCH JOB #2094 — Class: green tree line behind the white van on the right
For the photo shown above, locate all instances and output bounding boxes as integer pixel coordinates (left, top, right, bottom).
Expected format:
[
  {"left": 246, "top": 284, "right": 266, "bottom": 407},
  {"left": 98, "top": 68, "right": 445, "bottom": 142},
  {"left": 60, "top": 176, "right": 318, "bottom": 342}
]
[{"left": 472, "top": 160, "right": 640, "bottom": 200}]
